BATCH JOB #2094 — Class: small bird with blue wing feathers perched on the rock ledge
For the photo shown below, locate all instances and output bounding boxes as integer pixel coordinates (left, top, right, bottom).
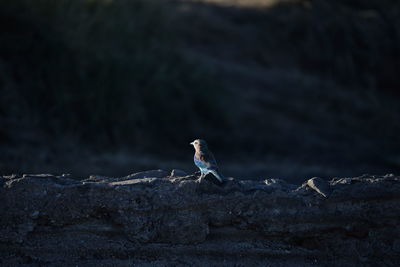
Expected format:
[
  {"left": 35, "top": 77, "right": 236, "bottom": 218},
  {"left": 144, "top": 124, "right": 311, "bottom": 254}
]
[{"left": 190, "top": 139, "right": 225, "bottom": 183}]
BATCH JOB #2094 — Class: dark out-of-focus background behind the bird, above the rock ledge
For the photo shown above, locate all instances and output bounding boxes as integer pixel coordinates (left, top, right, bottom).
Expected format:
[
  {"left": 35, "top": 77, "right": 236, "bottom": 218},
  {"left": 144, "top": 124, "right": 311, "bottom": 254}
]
[{"left": 0, "top": 0, "right": 400, "bottom": 183}]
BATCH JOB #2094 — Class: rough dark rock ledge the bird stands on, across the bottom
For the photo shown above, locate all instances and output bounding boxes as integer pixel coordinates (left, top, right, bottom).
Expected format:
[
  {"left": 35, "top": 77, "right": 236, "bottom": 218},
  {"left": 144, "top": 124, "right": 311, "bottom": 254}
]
[{"left": 0, "top": 173, "right": 400, "bottom": 266}]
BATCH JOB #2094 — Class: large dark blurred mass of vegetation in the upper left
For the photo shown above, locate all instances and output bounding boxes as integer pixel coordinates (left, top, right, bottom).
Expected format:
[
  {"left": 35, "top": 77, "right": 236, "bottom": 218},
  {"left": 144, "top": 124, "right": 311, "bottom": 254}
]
[{"left": 0, "top": 0, "right": 227, "bottom": 152}]
